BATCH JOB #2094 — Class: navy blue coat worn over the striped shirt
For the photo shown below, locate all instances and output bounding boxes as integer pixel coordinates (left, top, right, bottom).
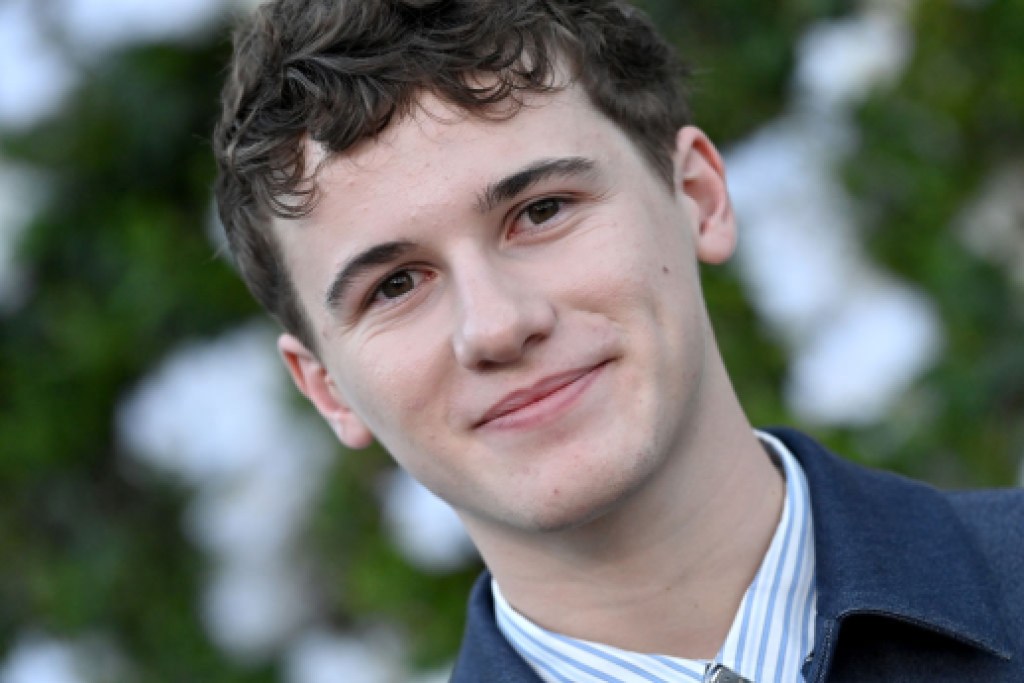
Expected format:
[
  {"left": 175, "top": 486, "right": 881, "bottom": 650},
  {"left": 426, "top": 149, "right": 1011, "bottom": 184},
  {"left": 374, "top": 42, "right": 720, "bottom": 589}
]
[{"left": 452, "top": 429, "right": 1024, "bottom": 683}]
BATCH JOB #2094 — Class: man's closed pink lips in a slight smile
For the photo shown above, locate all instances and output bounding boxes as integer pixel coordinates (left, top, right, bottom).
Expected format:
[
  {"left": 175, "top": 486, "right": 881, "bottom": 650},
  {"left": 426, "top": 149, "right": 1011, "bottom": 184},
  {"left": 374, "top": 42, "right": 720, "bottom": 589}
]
[{"left": 474, "top": 361, "right": 607, "bottom": 429}]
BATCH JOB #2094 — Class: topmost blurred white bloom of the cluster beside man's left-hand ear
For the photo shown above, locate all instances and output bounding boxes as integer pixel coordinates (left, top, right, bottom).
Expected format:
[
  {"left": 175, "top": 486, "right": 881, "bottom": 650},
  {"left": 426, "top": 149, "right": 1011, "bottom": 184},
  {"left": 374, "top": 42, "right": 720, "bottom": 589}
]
[{"left": 117, "top": 323, "right": 330, "bottom": 485}]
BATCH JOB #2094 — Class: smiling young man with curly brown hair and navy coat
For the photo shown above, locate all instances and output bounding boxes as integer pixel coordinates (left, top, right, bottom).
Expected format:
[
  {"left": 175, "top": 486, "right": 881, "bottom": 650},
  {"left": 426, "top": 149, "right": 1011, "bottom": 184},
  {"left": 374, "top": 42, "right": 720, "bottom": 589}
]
[{"left": 215, "top": 0, "right": 1024, "bottom": 682}]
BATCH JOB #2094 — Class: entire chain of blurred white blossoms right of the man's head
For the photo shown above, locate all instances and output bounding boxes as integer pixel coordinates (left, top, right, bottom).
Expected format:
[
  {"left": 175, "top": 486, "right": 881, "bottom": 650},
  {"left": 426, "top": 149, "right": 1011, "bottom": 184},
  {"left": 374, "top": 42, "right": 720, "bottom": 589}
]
[{"left": 726, "top": 7, "right": 942, "bottom": 424}]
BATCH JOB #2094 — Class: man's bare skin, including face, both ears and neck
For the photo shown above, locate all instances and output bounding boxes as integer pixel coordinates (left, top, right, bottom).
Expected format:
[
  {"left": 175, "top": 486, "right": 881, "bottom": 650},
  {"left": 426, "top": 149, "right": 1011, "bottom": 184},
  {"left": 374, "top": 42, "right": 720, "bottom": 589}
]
[{"left": 273, "top": 87, "right": 783, "bottom": 657}]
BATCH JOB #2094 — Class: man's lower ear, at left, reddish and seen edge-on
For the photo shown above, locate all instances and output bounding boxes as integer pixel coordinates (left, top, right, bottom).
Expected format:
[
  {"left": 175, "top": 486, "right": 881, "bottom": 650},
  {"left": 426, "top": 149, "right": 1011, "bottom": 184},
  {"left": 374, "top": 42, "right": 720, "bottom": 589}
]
[{"left": 278, "top": 334, "right": 374, "bottom": 449}]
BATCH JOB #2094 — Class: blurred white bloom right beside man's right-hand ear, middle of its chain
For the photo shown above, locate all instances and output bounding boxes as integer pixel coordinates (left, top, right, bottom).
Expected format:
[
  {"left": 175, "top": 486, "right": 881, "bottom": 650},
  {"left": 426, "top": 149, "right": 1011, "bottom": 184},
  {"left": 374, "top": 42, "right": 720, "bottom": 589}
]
[{"left": 726, "top": 116, "right": 864, "bottom": 343}]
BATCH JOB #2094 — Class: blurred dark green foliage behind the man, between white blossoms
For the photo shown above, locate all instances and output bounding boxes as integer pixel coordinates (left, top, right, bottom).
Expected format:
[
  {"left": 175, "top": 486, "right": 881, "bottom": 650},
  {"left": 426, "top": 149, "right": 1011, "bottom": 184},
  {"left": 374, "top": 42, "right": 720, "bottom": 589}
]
[{"left": 0, "top": 0, "right": 1024, "bottom": 683}]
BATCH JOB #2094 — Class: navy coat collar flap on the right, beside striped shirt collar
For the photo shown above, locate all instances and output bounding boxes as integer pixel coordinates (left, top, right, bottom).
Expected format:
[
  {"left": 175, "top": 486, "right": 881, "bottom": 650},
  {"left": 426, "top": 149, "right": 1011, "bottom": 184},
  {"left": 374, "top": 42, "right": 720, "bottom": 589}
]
[{"left": 767, "top": 429, "right": 1013, "bottom": 658}]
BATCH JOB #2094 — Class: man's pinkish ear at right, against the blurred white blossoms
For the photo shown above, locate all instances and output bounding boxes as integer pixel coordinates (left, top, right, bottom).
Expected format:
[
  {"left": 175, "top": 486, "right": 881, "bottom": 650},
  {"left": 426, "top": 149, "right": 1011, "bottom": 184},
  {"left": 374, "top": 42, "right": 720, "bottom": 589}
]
[{"left": 674, "top": 126, "right": 736, "bottom": 263}]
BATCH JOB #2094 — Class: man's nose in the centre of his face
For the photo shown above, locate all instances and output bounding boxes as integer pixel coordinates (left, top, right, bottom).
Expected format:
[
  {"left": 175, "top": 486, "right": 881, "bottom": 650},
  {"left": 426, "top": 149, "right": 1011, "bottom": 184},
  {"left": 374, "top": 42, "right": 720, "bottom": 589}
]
[{"left": 453, "top": 264, "right": 556, "bottom": 371}]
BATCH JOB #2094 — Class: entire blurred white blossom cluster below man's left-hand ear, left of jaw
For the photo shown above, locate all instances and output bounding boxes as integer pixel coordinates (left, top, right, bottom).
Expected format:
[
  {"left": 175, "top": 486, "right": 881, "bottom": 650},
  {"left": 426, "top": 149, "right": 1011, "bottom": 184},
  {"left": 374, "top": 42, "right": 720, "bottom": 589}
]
[{"left": 117, "top": 323, "right": 334, "bottom": 660}]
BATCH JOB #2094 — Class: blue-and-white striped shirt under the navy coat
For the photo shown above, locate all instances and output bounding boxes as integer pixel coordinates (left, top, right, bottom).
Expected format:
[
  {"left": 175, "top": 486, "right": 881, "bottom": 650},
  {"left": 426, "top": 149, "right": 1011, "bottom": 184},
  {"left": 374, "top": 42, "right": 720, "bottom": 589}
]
[{"left": 492, "top": 431, "right": 816, "bottom": 683}]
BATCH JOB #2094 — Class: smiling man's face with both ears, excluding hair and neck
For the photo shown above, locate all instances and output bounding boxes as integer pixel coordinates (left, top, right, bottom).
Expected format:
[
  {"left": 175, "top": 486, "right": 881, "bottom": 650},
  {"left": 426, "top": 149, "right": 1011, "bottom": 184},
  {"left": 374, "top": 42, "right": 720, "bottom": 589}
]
[{"left": 275, "top": 83, "right": 732, "bottom": 531}]
